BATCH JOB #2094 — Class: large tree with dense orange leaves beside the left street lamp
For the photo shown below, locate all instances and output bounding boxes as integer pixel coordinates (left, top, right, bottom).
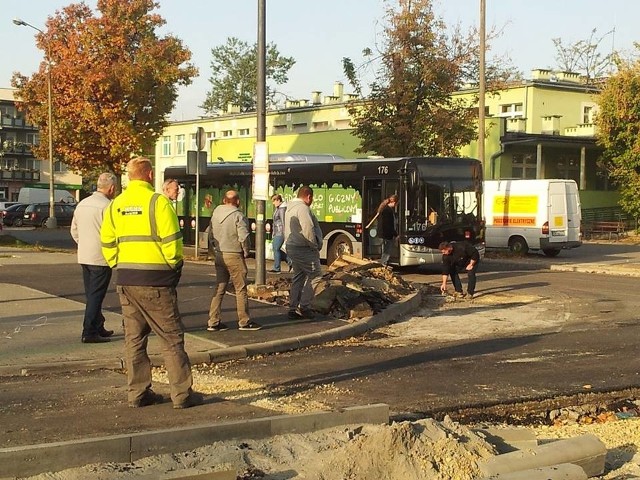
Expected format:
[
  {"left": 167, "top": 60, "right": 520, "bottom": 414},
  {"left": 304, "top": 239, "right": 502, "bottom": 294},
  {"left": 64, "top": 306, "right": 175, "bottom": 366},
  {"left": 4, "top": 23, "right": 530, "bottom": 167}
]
[{"left": 12, "top": 0, "right": 197, "bottom": 173}]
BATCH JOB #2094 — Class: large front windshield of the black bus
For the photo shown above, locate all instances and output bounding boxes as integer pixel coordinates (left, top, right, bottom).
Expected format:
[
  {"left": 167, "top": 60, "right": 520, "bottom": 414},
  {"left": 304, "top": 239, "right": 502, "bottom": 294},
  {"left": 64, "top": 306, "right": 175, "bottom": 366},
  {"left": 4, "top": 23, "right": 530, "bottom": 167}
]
[{"left": 405, "top": 179, "right": 480, "bottom": 234}]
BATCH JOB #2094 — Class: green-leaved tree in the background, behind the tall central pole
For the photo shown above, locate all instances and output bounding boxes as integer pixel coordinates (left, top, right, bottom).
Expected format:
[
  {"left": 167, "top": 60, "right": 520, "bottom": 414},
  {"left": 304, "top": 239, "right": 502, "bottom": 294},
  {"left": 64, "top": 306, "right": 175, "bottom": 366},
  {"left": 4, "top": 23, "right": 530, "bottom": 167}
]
[{"left": 200, "top": 37, "right": 296, "bottom": 114}]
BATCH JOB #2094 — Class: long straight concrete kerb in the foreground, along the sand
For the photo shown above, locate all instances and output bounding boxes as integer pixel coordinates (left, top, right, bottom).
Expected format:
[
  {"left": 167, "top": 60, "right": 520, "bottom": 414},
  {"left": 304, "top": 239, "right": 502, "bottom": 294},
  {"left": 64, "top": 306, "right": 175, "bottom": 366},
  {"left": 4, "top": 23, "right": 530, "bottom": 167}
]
[{"left": 0, "top": 403, "right": 389, "bottom": 478}]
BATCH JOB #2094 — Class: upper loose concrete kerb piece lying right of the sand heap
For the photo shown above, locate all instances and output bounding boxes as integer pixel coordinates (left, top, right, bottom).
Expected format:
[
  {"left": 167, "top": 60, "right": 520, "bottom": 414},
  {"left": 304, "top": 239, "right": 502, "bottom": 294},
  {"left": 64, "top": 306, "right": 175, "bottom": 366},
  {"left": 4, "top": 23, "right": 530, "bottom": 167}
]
[{"left": 480, "top": 434, "right": 607, "bottom": 478}]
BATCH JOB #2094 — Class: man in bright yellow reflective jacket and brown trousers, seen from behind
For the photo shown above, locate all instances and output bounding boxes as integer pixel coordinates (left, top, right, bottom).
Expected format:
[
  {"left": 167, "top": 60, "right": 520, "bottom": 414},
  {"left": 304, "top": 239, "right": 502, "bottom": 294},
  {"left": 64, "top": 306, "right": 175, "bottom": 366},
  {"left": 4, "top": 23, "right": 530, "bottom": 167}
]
[{"left": 100, "top": 157, "right": 203, "bottom": 408}]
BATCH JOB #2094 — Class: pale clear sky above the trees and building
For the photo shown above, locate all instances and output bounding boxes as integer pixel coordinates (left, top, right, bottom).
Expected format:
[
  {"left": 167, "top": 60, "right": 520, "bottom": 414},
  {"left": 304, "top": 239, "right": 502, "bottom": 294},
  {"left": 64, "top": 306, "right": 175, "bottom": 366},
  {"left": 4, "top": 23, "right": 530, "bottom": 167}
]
[{"left": 0, "top": 0, "right": 640, "bottom": 120}]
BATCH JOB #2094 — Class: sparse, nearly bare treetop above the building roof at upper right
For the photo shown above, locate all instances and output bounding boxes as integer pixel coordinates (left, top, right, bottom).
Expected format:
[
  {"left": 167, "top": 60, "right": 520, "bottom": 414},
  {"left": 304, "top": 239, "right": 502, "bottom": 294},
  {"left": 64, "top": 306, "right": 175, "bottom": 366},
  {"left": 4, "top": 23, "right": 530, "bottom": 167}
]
[{"left": 552, "top": 28, "right": 615, "bottom": 83}]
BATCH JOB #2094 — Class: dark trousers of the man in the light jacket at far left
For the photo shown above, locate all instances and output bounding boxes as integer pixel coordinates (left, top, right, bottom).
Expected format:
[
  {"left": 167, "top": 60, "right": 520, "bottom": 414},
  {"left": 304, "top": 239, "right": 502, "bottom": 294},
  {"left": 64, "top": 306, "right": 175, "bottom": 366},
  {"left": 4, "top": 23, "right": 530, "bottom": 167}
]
[{"left": 81, "top": 265, "right": 111, "bottom": 337}]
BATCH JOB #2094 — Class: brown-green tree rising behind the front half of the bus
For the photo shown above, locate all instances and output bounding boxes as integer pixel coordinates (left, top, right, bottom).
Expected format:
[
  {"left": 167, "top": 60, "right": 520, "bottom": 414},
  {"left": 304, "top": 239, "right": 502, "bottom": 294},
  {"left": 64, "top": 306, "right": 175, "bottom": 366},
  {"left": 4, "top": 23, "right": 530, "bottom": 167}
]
[{"left": 343, "top": 0, "right": 515, "bottom": 157}]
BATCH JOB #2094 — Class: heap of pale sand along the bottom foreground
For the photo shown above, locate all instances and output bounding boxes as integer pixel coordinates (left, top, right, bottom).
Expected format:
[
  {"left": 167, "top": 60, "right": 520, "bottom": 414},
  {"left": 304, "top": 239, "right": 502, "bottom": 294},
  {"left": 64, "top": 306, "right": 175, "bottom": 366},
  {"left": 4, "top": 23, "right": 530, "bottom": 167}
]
[{"left": 23, "top": 419, "right": 495, "bottom": 480}]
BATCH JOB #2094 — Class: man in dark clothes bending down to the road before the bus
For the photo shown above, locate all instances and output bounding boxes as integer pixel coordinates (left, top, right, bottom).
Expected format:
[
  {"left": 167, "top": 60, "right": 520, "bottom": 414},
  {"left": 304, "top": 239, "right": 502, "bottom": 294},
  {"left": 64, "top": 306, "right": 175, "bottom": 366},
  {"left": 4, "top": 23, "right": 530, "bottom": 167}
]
[{"left": 438, "top": 242, "right": 480, "bottom": 299}]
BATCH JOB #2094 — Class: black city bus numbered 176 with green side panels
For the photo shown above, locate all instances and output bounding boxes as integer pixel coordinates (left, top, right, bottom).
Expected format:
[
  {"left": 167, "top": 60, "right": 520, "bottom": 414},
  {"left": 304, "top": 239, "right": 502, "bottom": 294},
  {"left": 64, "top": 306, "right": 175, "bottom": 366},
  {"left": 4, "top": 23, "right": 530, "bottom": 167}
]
[{"left": 164, "top": 154, "right": 484, "bottom": 266}]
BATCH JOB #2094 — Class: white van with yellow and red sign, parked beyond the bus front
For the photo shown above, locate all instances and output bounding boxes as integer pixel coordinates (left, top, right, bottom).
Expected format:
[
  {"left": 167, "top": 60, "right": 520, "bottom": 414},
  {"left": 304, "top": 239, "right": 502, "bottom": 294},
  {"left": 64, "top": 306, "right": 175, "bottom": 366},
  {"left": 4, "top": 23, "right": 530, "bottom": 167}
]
[{"left": 483, "top": 179, "right": 582, "bottom": 257}]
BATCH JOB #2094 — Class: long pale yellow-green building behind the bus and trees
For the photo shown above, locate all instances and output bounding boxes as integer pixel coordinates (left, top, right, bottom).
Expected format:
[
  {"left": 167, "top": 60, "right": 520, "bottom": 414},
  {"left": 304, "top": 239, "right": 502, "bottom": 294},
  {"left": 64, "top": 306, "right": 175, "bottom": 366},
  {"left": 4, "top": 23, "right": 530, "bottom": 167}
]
[{"left": 155, "top": 69, "right": 618, "bottom": 208}]
